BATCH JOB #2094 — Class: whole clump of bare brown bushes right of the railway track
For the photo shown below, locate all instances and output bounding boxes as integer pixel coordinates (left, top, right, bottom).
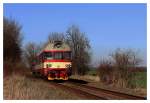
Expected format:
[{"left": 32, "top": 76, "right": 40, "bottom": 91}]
[{"left": 98, "top": 49, "right": 142, "bottom": 87}]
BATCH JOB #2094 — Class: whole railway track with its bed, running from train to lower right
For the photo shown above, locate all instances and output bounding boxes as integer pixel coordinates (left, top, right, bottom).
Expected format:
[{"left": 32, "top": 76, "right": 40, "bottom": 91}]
[{"left": 27, "top": 75, "right": 146, "bottom": 100}]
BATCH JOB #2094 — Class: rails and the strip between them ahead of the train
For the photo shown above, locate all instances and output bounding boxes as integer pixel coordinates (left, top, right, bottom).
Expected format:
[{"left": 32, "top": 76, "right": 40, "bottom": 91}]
[{"left": 64, "top": 81, "right": 146, "bottom": 100}]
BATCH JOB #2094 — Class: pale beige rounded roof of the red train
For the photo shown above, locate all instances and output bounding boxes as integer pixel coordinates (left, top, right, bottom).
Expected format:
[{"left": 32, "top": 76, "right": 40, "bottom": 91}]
[{"left": 39, "top": 41, "right": 71, "bottom": 54}]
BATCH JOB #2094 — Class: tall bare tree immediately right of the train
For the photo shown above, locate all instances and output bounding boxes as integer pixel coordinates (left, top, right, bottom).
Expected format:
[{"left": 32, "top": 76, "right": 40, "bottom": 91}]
[{"left": 66, "top": 25, "right": 90, "bottom": 75}]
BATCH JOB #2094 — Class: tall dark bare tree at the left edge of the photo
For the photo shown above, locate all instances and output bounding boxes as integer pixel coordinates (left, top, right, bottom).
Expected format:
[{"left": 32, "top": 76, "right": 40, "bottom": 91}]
[{"left": 3, "top": 17, "right": 23, "bottom": 75}]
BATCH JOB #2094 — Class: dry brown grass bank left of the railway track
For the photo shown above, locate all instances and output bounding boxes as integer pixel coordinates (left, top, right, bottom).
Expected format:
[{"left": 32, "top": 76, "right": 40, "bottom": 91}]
[{"left": 3, "top": 74, "right": 81, "bottom": 100}]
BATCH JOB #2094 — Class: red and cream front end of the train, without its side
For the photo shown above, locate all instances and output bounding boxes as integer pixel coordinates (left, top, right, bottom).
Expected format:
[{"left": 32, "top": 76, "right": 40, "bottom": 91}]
[{"left": 43, "top": 41, "right": 72, "bottom": 80}]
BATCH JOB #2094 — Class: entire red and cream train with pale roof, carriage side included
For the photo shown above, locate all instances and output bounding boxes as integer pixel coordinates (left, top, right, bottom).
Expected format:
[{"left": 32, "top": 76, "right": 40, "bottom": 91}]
[{"left": 32, "top": 41, "right": 72, "bottom": 80}]
